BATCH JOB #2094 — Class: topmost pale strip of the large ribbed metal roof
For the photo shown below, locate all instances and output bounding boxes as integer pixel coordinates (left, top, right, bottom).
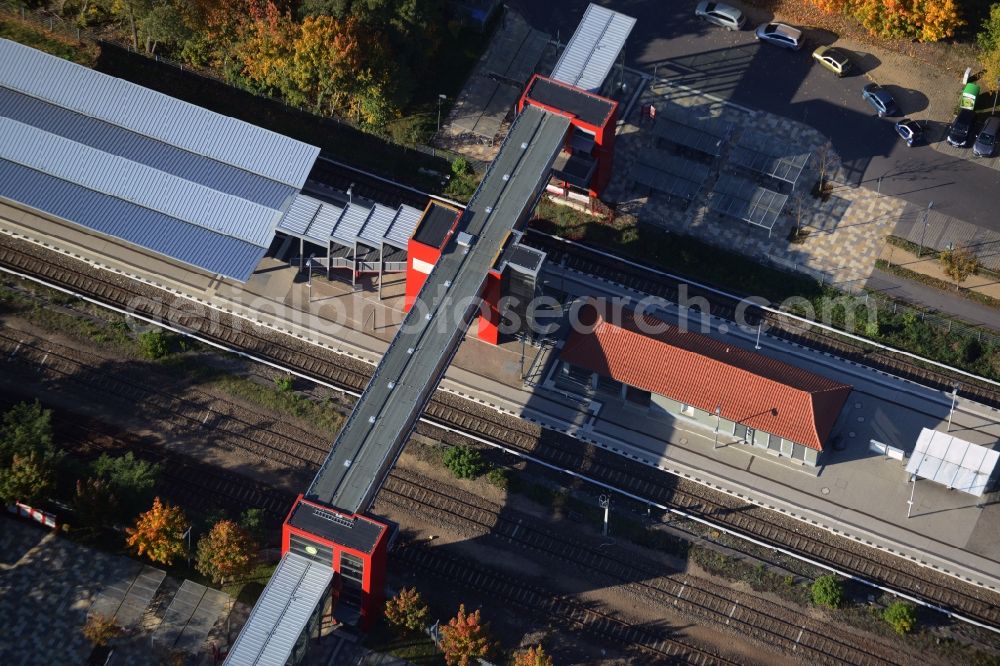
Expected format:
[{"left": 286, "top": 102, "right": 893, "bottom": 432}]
[{"left": 0, "top": 39, "right": 319, "bottom": 188}]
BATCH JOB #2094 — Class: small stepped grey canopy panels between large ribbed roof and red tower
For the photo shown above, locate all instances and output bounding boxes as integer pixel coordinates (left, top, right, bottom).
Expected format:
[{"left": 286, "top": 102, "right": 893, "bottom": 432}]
[{"left": 277, "top": 194, "right": 421, "bottom": 249}]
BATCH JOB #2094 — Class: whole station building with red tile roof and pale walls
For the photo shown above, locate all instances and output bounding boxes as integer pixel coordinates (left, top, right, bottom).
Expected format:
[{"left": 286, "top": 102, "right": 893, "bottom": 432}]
[{"left": 556, "top": 301, "right": 852, "bottom": 465}]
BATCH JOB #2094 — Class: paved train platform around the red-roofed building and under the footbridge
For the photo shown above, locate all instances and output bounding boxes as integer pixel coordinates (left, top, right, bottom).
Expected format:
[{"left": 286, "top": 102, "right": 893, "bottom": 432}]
[{"left": 0, "top": 206, "right": 1000, "bottom": 589}]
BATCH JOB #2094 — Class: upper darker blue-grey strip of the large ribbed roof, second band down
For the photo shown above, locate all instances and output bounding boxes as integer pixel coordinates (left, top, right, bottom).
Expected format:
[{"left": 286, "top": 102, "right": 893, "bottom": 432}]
[{"left": 0, "top": 86, "right": 295, "bottom": 210}]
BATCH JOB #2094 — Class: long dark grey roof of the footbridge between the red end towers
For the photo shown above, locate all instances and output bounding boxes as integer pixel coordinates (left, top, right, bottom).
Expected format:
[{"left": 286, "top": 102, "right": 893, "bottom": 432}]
[{"left": 306, "top": 106, "right": 569, "bottom": 514}]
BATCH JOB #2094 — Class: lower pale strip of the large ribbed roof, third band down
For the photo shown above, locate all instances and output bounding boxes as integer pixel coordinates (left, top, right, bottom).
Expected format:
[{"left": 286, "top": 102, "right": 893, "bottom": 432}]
[{"left": 0, "top": 117, "right": 280, "bottom": 247}]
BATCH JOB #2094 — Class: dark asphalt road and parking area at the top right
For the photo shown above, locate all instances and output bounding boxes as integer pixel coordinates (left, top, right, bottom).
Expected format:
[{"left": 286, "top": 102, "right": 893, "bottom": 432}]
[{"left": 507, "top": 0, "right": 1000, "bottom": 231}]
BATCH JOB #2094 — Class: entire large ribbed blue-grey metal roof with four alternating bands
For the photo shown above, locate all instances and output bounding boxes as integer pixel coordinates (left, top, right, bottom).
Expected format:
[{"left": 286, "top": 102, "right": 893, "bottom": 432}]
[{"left": 0, "top": 39, "right": 319, "bottom": 281}]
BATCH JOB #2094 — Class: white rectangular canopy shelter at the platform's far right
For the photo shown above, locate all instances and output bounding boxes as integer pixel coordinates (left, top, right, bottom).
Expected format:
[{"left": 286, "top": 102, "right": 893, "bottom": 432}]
[{"left": 906, "top": 428, "right": 1000, "bottom": 497}]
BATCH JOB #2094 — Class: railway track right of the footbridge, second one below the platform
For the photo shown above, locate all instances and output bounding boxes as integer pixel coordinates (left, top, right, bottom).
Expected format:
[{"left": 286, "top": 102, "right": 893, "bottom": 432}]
[{"left": 376, "top": 470, "right": 916, "bottom": 666}]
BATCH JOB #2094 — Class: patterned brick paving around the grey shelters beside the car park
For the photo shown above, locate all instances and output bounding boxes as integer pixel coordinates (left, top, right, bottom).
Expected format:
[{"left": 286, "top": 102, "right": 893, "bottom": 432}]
[{"left": 608, "top": 82, "right": 906, "bottom": 287}]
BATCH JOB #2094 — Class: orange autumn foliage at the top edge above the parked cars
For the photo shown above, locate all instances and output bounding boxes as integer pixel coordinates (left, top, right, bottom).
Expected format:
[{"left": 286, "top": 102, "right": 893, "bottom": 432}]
[{"left": 810, "top": 0, "right": 965, "bottom": 42}]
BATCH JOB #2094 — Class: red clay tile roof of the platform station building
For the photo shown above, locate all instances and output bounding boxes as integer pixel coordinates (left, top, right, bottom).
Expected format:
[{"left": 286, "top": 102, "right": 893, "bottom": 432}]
[{"left": 560, "top": 303, "right": 851, "bottom": 451}]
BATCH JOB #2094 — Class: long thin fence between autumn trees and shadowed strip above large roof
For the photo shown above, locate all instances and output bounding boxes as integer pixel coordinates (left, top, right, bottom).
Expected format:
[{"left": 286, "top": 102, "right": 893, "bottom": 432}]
[{"left": 0, "top": 0, "right": 488, "bottom": 173}]
